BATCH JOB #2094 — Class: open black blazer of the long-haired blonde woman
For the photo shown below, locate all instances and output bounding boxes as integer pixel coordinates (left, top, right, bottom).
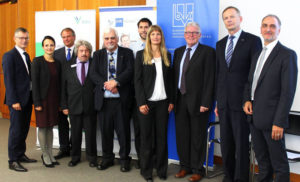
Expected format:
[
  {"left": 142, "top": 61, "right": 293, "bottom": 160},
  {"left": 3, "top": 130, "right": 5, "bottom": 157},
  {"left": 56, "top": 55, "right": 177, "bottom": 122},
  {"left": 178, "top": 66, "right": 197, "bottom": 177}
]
[{"left": 134, "top": 50, "right": 174, "bottom": 106}]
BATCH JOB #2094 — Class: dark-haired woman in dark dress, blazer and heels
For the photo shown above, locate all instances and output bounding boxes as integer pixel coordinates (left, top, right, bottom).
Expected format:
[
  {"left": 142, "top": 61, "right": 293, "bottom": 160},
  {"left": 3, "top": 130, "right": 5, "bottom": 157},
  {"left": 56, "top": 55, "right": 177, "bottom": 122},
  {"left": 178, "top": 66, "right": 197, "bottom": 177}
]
[{"left": 31, "top": 36, "right": 61, "bottom": 167}]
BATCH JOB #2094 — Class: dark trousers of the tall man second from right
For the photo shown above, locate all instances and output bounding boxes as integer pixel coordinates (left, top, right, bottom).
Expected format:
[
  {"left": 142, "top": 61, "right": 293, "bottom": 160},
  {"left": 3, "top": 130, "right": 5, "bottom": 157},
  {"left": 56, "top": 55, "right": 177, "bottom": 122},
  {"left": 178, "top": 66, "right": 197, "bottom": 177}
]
[{"left": 219, "top": 108, "right": 250, "bottom": 182}]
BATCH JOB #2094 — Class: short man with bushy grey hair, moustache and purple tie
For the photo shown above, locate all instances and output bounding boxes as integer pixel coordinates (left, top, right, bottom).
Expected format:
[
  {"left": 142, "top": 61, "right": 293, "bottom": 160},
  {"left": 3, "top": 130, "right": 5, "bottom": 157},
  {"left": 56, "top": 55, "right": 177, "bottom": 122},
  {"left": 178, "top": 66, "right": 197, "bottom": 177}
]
[{"left": 61, "top": 40, "right": 97, "bottom": 167}]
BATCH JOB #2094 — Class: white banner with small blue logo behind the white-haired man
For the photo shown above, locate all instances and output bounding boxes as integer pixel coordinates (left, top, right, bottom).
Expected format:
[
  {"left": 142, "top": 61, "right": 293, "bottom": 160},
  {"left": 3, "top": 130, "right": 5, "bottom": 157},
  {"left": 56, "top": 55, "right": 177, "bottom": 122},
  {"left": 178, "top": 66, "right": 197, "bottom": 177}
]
[{"left": 97, "top": 6, "right": 156, "bottom": 157}]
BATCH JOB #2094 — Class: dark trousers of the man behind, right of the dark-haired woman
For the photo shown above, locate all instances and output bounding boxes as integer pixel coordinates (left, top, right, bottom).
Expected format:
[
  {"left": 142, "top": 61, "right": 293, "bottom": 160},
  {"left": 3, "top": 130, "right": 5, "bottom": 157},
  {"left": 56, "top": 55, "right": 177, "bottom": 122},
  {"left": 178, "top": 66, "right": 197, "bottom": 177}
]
[{"left": 58, "top": 112, "right": 71, "bottom": 152}]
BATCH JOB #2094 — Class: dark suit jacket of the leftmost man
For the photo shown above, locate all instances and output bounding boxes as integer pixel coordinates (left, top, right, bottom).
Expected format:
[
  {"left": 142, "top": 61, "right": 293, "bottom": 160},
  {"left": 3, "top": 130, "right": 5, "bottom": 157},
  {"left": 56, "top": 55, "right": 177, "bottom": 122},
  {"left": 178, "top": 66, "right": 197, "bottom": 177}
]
[{"left": 2, "top": 47, "right": 32, "bottom": 106}]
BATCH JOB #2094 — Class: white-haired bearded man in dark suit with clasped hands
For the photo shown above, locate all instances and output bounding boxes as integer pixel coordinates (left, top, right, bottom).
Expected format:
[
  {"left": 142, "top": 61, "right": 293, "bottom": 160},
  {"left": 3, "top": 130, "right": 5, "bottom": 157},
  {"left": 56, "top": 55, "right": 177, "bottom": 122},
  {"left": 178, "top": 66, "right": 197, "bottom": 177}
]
[{"left": 91, "top": 28, "right": 134, "bottom": 172}]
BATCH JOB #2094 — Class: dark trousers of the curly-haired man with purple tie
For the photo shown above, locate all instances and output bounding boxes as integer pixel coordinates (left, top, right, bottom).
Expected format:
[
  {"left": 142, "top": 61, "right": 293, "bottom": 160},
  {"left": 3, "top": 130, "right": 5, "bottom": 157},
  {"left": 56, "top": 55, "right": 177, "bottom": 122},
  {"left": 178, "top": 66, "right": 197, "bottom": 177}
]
[{"left": 70, "top": 114, "right": 97, "bottom": 162}]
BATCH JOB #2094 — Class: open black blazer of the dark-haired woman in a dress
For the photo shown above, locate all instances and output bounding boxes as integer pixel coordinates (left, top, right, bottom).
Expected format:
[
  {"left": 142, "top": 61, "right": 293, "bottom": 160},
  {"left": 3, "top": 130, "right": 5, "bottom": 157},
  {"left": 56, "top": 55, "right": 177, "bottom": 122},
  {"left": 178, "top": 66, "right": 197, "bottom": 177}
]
[{"left": 31, "top": 56, "right": 61, "bottom": 107}]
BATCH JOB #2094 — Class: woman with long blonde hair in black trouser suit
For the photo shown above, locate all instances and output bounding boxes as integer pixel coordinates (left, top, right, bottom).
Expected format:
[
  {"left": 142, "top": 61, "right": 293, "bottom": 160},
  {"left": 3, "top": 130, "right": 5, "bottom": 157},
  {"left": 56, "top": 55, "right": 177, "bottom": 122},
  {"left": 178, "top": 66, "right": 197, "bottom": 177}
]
[{"left": 134, "top": 25, "right": 174, "bottom": 181}]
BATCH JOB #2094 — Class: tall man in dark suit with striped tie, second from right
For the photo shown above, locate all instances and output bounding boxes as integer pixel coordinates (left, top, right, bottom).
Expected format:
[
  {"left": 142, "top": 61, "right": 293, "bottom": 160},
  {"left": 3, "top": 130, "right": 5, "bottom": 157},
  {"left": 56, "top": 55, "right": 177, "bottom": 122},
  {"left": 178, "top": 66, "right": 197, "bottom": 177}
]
[{"left": 215, "top": 6, "right": 262, "bottom": 182}]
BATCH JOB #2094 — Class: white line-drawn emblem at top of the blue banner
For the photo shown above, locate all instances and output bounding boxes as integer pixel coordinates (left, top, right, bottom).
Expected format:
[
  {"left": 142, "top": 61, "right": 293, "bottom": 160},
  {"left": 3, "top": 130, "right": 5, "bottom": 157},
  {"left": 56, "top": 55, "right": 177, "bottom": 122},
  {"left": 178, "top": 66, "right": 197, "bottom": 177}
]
[{"left": 173, "top": 3, "right": 194, "bottom": 27}]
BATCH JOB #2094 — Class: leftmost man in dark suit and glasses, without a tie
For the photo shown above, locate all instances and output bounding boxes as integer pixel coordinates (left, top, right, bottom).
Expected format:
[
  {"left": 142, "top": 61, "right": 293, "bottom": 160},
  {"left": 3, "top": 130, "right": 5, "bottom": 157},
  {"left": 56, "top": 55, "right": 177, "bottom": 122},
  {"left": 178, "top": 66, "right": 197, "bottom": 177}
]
[{"left": 2, "top": 27, "right": 36, "bottom": 172}]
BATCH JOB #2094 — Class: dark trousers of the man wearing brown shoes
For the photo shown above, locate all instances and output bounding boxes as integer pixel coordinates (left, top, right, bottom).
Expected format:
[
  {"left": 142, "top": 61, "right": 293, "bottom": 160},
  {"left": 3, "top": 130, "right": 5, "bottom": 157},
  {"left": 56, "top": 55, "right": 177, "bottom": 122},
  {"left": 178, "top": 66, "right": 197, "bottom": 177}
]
[{"left": 175, "top": 93, "right": 209, "bottom": 175}]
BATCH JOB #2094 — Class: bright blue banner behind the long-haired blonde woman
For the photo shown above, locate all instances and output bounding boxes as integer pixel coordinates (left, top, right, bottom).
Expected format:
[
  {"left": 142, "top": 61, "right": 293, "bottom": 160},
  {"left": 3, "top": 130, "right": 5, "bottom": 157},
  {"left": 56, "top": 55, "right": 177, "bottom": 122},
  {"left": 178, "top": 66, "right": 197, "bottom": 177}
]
[{"left": 157, "top": 0, "right": 219, "bottom": 166}]
